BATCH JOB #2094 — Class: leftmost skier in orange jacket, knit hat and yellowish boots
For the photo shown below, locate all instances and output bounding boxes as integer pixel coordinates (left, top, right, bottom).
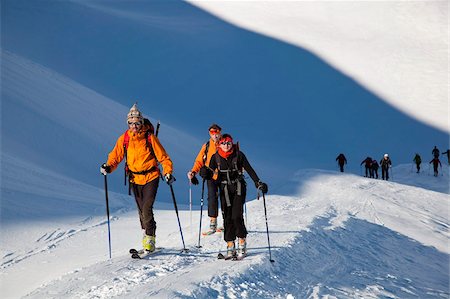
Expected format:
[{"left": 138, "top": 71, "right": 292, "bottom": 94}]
[{"left": 100, "top": 104, "right": 175, "bottom": 252}]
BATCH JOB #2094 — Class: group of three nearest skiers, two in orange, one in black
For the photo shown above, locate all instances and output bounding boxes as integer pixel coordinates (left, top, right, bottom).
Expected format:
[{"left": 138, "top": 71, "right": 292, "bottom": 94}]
[{"left": 100, "top": 104, "right": 270, "bottom": 259}]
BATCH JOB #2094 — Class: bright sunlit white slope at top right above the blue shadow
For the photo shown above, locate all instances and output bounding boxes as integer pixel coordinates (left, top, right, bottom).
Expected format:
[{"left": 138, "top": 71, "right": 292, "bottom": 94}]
[{"left": 189, "top": 1, "right": 450, "bottom": 132}]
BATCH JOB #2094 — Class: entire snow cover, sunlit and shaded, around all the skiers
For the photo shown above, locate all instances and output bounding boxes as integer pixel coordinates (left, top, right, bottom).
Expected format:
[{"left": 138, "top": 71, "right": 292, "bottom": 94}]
[{"left": 0, "top": 0, "right": 449, "bottom": 298}]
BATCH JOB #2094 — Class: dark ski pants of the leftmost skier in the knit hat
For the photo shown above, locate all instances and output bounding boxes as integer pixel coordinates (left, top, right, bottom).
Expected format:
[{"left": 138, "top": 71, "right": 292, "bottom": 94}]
[{"left": 133, "top": 177, "right": 159, "bottom": 236}]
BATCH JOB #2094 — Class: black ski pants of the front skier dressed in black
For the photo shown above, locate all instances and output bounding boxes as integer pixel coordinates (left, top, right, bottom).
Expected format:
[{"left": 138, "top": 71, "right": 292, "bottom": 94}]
[{"left": 220, "top": 183, "right": 247, "bottom": 242}]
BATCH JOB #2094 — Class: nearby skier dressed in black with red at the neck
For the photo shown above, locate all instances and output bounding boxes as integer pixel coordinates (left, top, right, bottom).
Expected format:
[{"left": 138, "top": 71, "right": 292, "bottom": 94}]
[{"left": 202, "top": 134, "right": 268, "bottom": 259}]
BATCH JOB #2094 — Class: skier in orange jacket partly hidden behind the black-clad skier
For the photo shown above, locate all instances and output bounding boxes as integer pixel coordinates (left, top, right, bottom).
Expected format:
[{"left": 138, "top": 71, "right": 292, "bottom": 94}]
[{"left": 187, "top": 124, "right": 222, "bottom": 235}]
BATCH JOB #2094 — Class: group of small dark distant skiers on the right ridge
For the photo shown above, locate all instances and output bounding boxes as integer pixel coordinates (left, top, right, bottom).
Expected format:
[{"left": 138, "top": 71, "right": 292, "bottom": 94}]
[{"left": 336, "top": 146, "right": 450, "bottom": 181}]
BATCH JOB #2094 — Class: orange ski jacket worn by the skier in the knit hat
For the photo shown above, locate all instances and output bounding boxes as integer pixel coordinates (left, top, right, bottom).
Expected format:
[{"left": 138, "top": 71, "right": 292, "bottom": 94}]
[{"left": 106, "top": 130, "right": 173, "bottom": 185}]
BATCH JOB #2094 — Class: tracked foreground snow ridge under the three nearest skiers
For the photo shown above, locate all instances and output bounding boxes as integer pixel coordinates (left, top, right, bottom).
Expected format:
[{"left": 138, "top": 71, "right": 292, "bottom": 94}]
[{"left": 1, "top": 166, "right": 450, "bottom": 298}]
